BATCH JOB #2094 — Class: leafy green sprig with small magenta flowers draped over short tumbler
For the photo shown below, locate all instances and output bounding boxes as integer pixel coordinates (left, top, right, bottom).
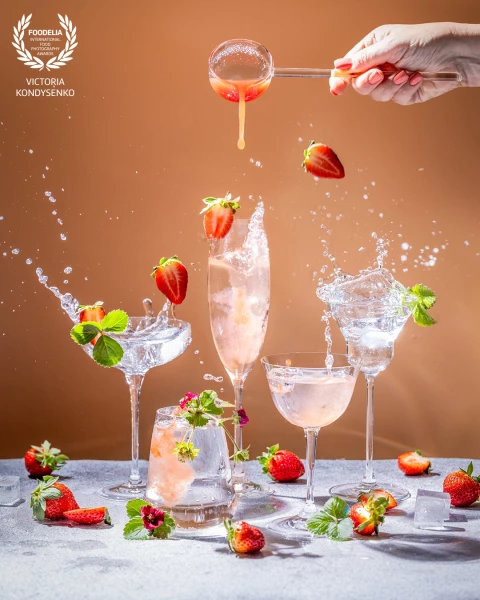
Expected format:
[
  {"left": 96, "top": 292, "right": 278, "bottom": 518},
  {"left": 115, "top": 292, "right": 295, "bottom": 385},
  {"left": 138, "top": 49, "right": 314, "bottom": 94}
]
[{"left": 174, "top": 390, "right": 249, "bottom": 464}]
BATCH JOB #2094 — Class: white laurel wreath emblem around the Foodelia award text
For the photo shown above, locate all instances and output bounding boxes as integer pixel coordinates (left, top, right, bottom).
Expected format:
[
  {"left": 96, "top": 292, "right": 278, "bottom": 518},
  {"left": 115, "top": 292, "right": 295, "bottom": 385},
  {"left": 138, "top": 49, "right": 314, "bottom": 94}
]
[{"left": 12, "top": 13, "right": 78, "bottom": 71}]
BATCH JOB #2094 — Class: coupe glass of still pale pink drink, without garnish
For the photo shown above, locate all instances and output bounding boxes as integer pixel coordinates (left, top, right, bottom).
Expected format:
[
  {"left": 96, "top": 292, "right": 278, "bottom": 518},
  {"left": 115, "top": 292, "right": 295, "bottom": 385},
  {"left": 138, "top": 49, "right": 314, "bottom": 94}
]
[{"left": 261, "top": 352, "right": 358, "bottom": 537}]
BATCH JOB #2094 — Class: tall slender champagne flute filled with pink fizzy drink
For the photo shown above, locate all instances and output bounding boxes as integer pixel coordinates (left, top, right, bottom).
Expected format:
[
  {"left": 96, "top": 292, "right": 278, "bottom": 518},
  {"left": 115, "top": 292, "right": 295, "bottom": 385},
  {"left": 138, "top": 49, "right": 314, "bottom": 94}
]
[{"left": 208, "top": 218, "right": 270, "bottom": 494}]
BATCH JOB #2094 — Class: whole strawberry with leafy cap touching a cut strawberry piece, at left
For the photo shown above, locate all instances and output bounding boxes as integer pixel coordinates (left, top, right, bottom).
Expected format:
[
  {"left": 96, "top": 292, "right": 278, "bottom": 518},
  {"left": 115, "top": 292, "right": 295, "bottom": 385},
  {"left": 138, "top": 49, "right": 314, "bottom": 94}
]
[{"left": 30, "top": 475, "right": 79, "bottom": 521}]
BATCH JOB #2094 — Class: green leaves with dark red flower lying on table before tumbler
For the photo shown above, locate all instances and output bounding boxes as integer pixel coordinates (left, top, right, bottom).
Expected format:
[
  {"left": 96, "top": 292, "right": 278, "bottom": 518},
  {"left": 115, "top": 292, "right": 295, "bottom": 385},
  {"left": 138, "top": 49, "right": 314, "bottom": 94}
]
[{"left": 123, "top": 499, "right": 175, "bottom": 540}]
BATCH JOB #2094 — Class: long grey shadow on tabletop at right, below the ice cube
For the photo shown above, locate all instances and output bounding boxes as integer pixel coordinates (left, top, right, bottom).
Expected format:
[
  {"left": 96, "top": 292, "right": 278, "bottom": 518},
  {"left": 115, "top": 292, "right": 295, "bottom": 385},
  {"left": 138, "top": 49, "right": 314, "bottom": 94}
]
[{"left": 362, "top": 527, "right": 480, "bottom": 562}]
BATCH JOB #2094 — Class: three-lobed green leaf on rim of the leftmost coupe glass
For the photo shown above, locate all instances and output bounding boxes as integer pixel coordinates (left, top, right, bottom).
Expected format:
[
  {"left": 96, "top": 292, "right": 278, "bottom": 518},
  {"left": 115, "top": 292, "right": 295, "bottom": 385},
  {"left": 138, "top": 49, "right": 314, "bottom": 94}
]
[{"left": 70, "top": 310, "right": 128, "bottom": 367}]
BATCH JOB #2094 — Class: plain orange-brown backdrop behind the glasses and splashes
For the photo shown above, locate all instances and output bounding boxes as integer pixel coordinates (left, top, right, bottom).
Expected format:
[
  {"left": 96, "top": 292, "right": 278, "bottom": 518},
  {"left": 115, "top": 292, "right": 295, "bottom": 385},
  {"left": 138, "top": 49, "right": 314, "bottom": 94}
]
[{"left": 0, "top": 0, "right": 480, "bottom": 459}]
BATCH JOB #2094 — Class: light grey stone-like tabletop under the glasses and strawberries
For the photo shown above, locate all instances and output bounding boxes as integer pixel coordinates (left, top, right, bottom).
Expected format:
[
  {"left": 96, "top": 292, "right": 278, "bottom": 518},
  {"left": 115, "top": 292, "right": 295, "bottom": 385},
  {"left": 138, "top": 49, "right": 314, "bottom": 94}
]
[{"left": 0, "top": 459, "right": 480, "bottom": 600}]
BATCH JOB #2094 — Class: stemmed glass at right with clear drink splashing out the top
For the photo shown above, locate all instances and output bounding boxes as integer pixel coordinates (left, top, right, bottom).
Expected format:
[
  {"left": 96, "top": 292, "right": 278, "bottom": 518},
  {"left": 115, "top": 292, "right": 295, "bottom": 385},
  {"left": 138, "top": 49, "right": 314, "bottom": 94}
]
[{"left": 330, "top": 300, "right": 411, "bottom": 502}]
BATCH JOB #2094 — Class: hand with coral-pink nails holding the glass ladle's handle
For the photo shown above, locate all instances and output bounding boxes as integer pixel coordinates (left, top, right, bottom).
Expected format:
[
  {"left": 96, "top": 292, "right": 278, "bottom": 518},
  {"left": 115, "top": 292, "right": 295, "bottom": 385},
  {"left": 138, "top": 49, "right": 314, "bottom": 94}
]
[{"left": 330, "top": 23, "right": 480, "bottom": 105}]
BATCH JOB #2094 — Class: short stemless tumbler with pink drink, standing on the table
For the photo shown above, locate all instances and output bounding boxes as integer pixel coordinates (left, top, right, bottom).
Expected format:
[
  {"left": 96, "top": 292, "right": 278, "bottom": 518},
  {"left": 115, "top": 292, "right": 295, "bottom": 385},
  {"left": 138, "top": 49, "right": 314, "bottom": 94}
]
[{"left": 145, "top": 406, "right": 236, "bottom": 533}]
